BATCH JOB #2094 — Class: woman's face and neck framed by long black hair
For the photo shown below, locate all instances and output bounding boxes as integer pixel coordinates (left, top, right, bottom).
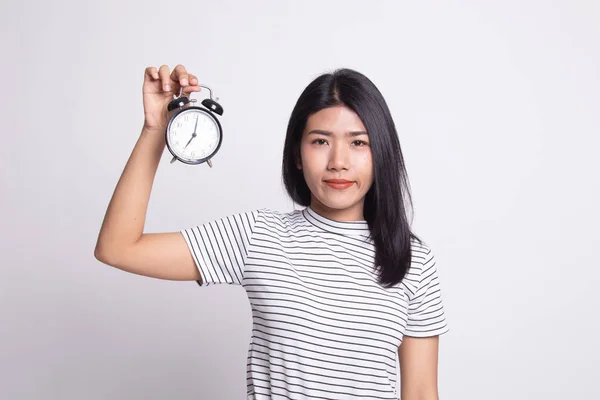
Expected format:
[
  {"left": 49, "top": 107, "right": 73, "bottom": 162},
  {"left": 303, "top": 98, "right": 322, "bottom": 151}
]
[{"left": 297, "top": 106, "right": 373, "bottom": 221}]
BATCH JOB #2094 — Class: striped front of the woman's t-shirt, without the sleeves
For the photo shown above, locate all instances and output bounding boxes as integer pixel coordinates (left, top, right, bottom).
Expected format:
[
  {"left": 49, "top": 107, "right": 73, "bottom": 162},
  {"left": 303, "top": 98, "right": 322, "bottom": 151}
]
[{"left": 243, "top": 209, "right": 408, "bottom": 399}]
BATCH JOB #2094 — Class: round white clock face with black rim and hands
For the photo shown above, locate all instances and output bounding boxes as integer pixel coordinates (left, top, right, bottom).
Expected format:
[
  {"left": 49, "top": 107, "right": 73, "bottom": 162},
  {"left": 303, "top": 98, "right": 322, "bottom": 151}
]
[{"left": 167, "top": 108, "right": 221, "bottom": 163}]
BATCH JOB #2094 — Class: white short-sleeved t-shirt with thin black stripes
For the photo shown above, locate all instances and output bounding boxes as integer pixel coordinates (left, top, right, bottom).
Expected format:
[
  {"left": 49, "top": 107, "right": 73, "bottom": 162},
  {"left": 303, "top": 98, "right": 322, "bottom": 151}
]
[{"left": 182, "top": 207, "right": 448, "bottom": 400}]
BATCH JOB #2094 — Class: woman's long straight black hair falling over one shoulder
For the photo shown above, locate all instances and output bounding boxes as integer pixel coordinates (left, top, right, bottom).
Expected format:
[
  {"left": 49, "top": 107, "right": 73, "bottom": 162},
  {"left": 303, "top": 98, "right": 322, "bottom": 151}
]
[{"left": 282, "top": 68, "right": 421, "bottom": 287}]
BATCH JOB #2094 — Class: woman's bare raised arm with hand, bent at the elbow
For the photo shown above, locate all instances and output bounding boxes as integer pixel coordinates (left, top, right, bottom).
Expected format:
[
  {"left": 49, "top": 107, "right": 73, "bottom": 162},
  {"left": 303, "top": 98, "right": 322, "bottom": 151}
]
[{"left": 94, "top": 65, "right": 201, "bottom": 281}]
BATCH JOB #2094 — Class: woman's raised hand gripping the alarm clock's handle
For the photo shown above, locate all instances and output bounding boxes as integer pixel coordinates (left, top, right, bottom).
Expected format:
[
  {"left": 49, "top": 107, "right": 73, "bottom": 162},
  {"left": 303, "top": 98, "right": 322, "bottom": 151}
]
[{"left": 142, "top": 64, "right": 200, "bottom": 132}]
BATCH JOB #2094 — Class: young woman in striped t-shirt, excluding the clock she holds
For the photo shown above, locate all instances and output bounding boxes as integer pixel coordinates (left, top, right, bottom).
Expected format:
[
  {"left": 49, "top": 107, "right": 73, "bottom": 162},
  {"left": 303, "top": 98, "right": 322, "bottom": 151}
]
[{"left": 95, "top": 65, "right": 448, "bottom": 400}]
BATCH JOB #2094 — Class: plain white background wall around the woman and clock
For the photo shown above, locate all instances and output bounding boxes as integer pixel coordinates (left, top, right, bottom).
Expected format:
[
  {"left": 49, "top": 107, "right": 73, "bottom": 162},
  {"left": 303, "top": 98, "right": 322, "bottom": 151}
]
[{"left": 0, "top": 0, "right": 600, "bottom": 400}]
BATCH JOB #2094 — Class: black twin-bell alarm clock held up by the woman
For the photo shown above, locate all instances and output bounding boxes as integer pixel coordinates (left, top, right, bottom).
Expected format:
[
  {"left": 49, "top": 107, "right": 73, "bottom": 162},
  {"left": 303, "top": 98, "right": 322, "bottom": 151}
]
[{"left": 165, "top": 85, "right": 223, "bottom": 168}]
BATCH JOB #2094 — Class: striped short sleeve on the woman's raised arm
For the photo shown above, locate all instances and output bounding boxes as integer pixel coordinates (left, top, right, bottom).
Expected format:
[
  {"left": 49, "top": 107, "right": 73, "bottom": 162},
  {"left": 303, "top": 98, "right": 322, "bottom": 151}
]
[{"left": 181, "top": 210, "right": 259, "bottom": 286}]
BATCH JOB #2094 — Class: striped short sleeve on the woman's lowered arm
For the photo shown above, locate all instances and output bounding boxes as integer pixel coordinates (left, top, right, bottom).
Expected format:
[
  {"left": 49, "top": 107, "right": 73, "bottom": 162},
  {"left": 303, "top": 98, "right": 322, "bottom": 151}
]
[{"left": 405, "top": 248, "right": 449, "bottom": 337}]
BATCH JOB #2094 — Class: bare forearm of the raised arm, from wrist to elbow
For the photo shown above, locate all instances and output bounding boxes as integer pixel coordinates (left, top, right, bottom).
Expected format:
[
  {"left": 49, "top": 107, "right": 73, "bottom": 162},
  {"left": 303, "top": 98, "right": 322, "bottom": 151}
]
[{"left": 95, "top": 128, "right": 165, "bottom": 256}]
